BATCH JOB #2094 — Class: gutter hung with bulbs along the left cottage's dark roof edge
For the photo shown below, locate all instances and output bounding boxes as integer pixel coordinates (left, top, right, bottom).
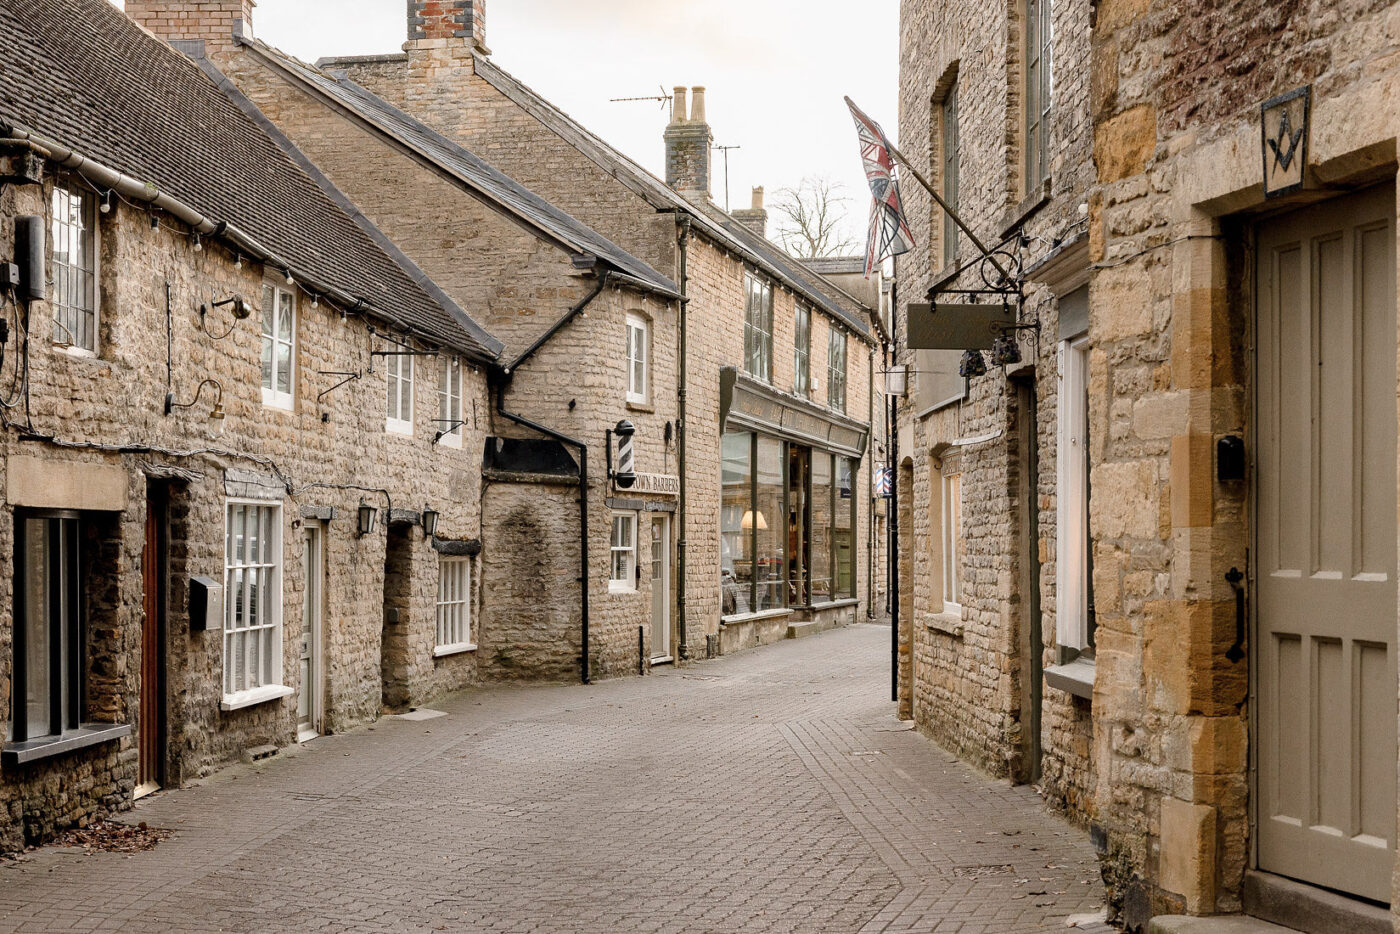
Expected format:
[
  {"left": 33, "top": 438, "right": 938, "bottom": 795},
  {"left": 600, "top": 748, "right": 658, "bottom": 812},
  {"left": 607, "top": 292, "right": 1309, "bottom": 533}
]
[{"left": 0, "top": 123, "right": 464, "bottom": 356}]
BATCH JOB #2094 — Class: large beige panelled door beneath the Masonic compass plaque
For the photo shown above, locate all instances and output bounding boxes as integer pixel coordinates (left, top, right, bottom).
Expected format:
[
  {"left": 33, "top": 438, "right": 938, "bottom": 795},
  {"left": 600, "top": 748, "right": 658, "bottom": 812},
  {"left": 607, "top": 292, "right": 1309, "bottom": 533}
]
[{"left": 1253, "top": 186, "right": 1396, "bottom": 902}]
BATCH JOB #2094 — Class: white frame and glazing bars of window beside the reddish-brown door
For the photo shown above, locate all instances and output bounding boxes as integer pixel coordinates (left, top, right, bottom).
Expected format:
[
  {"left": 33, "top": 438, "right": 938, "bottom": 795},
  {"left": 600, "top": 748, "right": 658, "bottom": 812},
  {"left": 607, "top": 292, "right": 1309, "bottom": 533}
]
[{"left": 218, "top": 499, "right": 293, "bottom": 710}]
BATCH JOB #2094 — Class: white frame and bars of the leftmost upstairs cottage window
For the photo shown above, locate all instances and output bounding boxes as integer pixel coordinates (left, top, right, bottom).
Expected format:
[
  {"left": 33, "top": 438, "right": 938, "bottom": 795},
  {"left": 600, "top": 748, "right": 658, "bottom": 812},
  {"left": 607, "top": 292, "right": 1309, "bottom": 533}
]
[{"left": 49, "top": 182, "right": 102, "bottom": 357}]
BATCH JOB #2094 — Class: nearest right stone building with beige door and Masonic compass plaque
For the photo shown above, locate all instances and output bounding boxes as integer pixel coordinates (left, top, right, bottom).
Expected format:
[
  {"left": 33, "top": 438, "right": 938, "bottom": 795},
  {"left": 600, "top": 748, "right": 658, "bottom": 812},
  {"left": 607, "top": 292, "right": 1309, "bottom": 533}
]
[{"left": 1089, "top": 0, "right": 1400, "bottom": 931}]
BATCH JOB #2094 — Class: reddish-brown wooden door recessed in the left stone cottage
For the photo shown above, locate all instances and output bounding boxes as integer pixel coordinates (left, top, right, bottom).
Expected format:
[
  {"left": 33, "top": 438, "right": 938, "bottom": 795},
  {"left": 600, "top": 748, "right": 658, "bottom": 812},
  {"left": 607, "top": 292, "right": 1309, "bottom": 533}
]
[{"left": 134, "top": 487, "right": 165, "bottom": 798}]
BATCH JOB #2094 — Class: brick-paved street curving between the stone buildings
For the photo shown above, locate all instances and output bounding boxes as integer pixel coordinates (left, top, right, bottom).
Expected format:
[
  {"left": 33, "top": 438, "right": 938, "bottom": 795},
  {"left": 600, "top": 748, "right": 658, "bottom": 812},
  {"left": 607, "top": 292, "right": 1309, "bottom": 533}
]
[{"left": 0, "top": 626, "right": 1109, "bottom": 934}]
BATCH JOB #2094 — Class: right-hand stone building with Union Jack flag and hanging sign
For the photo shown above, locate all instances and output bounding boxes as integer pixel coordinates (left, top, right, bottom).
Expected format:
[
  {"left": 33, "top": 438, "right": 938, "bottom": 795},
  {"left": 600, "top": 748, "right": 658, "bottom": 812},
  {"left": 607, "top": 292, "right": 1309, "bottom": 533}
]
[{"left": 896, "top": 0, "right": 1095, "bottom": 806}]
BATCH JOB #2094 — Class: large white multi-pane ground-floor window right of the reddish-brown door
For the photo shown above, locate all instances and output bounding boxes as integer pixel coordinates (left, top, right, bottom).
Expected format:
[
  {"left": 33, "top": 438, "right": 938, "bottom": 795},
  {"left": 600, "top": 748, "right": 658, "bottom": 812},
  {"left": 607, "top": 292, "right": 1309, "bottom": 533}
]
[{"left": 220, "top": 500, "right": 293, "bottom": 710}]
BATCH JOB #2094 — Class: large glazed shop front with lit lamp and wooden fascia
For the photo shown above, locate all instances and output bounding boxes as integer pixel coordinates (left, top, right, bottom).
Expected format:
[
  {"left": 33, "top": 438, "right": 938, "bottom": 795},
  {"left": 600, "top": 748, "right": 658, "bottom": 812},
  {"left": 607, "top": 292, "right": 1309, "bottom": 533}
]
[{"left": 720, "top": 368, "right": 869, "bottom": 650}]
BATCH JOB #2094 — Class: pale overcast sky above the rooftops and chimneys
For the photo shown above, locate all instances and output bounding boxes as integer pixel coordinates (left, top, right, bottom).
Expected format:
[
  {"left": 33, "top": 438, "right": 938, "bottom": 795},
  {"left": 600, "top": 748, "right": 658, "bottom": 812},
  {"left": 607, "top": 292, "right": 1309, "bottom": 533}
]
[{"left": 117, "top": 0, "right": 899, "bottom": 252}]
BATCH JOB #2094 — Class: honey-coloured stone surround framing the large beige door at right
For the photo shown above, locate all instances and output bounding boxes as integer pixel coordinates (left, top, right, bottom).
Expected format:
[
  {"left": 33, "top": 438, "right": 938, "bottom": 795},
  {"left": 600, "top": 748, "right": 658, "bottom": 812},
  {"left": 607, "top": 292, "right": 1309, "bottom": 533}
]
[{"left": 1091, "top": 64, "right": 1400, "bottom": 930}]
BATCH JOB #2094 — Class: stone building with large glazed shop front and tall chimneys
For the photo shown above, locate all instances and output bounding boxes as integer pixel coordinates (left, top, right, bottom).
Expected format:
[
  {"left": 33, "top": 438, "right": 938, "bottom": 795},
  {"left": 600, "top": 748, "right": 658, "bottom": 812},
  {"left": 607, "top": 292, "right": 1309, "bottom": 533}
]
[{"left": 318, "top": 0, "right": 879, "bottom": 658}]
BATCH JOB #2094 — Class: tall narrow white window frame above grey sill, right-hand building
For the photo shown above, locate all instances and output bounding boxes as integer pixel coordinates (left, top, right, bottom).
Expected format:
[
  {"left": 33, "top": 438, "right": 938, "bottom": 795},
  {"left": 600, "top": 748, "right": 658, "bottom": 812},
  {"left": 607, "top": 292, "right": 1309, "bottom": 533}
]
[{"left": 1056, "top": 336, "right": 1089, "bottom": 651}]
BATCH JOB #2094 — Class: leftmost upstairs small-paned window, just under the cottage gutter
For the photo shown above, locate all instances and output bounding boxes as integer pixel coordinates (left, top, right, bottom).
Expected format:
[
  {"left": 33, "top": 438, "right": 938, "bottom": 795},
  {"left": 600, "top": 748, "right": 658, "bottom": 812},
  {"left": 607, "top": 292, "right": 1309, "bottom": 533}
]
[{"left": 49, "top": 183, "right": 99, "bottom": 354}]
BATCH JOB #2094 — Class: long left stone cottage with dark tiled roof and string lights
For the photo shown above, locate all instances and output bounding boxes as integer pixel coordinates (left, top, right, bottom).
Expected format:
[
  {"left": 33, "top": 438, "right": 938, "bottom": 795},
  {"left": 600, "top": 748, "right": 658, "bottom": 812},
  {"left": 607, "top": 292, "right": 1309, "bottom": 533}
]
[{"left": 0, "top": 0, "right": 503, "bottom": 849}]
